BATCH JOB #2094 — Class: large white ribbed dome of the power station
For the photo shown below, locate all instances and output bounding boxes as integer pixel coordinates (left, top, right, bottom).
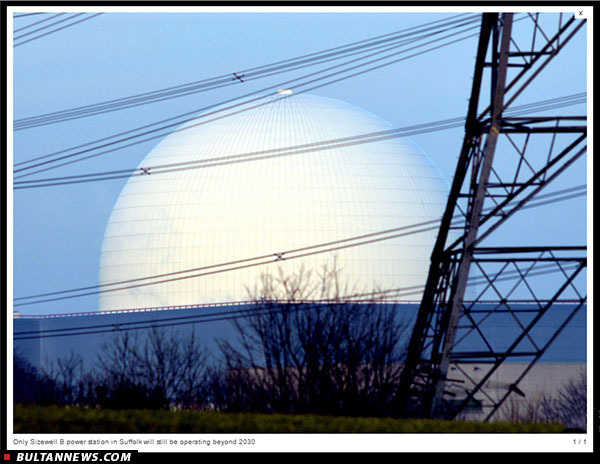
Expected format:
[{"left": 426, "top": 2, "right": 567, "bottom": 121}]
[{"left": 100, "top": 92, "right": 448, "bottom": 310}]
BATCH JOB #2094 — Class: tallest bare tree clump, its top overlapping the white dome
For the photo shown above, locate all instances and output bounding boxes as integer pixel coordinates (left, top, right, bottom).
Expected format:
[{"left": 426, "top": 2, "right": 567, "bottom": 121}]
[{"left": 214, "top": 261, "right": 407, "bottom": 415}]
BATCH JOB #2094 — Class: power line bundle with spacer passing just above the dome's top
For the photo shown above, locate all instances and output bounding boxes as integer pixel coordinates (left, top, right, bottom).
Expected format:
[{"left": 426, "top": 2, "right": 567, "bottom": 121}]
[{"left": 14, "top": 15, "right": 477, "bottom": 130}]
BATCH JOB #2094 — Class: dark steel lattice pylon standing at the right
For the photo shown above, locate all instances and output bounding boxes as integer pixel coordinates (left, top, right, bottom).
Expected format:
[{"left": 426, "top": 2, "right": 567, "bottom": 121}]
[{"left": 397, "top": 13, "right": 587, "bottom": 420}]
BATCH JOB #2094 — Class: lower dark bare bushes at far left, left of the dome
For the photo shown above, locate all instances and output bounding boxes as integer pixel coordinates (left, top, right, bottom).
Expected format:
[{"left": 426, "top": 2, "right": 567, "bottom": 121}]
[{"left": 13, "top": 328, "right": 214, "bottom": 409}]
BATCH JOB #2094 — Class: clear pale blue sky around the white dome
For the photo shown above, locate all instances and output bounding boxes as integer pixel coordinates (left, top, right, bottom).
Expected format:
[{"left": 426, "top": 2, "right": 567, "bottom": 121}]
[{"left": 8, "top": 7, "right": 589, "bottom": 315}]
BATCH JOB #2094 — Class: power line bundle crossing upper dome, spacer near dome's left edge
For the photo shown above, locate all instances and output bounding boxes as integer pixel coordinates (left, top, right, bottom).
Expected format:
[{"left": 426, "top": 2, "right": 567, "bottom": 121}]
[{"left": 13, "top": 93, "right": 586, "bottom": 190}]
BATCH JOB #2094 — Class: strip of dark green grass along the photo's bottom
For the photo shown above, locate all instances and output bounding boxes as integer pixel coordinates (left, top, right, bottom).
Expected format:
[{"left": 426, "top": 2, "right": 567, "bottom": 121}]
[{"left": 14, "top": 405, "right": 564, "bottom": 433}]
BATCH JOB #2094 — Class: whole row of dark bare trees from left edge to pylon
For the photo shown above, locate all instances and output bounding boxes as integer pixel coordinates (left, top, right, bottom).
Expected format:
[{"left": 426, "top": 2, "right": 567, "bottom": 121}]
[{"left": 14, "top": 263, "right": 407, "bottom": 416}]
